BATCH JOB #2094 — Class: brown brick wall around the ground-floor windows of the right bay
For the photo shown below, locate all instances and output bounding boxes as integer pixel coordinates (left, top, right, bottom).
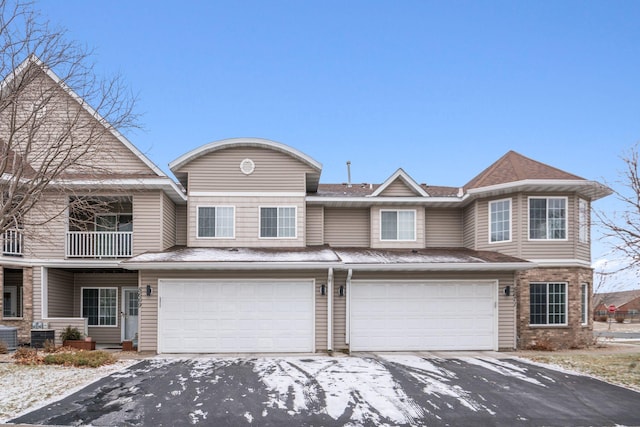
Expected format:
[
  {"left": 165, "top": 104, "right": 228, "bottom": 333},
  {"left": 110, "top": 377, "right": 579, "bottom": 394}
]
[{"left": 516, "top": 267, "right": 593, "bottom": 349}]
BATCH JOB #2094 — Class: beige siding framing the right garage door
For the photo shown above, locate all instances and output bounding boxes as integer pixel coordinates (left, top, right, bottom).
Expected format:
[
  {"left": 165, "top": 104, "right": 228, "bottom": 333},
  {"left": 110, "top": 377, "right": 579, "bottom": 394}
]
[{"left": 334, "top": 271, "right": 516, "bottom": 350}]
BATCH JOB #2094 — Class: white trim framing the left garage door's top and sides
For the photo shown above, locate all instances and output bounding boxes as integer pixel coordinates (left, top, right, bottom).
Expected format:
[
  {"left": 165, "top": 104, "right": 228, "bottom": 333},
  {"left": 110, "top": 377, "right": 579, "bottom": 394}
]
[{"left": 157, "top": 278, "right": 316, "bottom": 354}]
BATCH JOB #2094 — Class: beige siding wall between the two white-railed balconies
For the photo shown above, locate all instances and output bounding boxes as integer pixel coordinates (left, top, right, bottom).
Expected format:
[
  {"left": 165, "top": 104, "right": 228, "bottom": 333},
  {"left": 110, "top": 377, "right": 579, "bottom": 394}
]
[{"left": 23, "top": 192, "right": 69, "bottom": 259}]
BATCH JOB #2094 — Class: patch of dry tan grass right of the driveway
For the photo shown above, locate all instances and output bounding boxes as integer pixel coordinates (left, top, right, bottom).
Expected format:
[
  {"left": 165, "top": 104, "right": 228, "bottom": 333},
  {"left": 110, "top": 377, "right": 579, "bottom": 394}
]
[{"left": 525, "top": 352, "right": 640, "bottom": 391}]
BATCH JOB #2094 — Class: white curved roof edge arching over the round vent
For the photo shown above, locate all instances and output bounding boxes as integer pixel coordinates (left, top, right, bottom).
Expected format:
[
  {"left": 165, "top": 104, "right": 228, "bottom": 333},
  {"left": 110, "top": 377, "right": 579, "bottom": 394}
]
[{"left": 169, "top": 138, "right": 322, "bottom": 173}]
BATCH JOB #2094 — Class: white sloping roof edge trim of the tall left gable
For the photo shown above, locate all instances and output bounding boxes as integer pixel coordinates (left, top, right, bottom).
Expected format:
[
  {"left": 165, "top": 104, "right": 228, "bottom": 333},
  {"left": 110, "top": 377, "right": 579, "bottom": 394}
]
[{"left": 0, "top": 54, "right": 168, "bottom": 178}]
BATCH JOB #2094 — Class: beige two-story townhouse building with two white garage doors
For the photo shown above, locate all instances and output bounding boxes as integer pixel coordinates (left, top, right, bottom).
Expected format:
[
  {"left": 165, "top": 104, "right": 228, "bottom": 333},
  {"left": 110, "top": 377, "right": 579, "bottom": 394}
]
[{"left": 0, "top": 57, "right": 611, "bottom": 353}]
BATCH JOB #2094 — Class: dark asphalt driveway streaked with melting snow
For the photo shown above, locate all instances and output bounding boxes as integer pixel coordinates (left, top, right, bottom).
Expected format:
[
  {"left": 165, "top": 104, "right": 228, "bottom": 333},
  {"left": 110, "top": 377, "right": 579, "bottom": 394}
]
[{"left": 12, "top": 355, "right": 640, "bottom": 426}]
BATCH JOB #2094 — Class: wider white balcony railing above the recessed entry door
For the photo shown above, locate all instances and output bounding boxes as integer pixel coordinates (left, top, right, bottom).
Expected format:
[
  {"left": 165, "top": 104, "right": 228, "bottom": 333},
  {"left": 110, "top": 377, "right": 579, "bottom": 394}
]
[{"left": 66, "top": 231, "right": 133, "bottom": 258}]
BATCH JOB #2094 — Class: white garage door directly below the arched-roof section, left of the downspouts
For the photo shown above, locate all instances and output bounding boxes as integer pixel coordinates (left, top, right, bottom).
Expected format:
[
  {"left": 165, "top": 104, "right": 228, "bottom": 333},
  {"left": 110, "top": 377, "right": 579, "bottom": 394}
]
[{"left": 158, "top": 280, "right": 314, "bottom": 353}]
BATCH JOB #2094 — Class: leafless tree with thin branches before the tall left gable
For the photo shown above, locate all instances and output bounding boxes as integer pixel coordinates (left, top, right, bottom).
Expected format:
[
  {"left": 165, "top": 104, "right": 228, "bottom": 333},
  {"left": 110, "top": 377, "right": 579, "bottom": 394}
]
[{"left": 0, "top": 0, "right": 137, "bottom": 241}]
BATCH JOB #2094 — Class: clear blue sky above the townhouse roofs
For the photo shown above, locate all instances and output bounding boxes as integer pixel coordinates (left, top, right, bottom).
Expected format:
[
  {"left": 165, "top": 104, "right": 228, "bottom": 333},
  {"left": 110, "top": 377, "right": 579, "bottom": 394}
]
[{"left": 35, "top": 0, "right": 640, "bottom": 286}]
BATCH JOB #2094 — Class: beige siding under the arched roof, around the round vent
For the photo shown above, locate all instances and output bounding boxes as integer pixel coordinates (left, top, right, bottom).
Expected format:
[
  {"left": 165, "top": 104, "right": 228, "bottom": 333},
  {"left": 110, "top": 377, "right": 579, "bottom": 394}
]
[{"left": 175, "top": 147, "right": 313, "bottom": 193}]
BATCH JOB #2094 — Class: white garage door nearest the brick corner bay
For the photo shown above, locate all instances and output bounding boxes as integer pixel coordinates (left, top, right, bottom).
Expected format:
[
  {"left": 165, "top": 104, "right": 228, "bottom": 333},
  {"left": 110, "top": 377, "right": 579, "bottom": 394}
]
[{"left": 349, "top": 281, "right": 497, "bottom": 351}]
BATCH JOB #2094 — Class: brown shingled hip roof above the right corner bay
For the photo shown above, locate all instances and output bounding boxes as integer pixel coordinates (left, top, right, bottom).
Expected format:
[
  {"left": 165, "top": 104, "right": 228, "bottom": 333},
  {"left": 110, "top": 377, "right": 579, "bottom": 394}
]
[{"left": 464, "top": 150, "right": 584, "bottom": 190}]
